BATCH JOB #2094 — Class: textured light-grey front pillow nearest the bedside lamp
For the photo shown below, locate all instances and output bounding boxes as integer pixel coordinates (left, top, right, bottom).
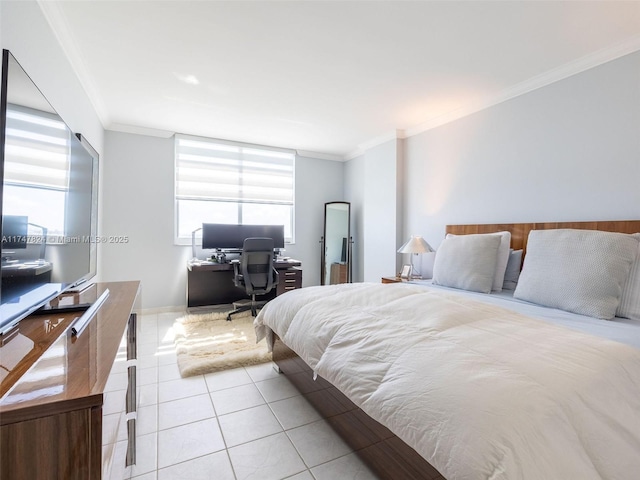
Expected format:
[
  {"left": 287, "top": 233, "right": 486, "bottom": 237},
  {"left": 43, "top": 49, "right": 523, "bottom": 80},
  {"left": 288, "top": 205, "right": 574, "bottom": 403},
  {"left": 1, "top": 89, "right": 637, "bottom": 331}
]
[{"left": 433, "top": 235, "right": 500, "bottom": 293}]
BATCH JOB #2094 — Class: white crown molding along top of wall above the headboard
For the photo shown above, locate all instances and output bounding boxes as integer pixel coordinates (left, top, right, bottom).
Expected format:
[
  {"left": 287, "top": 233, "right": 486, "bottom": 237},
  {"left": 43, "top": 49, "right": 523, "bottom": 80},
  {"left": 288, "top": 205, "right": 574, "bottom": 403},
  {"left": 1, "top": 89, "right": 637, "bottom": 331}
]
[{"left": 406, "top": 35, "right": 640, "bottom": 137}]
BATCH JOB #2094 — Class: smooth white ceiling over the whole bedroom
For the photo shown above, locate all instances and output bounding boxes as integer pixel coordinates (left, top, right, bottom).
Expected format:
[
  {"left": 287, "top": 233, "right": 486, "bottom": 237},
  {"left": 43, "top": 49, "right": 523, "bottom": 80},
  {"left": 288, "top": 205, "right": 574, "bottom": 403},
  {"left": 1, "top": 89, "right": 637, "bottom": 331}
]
[{"left": 39, "top": 0, "right": 640, "bottom": 159}]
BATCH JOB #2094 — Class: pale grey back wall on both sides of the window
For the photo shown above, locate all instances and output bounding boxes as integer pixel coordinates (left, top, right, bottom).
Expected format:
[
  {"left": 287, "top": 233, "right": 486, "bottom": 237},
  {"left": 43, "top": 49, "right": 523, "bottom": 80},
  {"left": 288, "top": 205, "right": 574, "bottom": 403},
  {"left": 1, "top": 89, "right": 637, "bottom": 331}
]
[{"left": 102, "top": 131, "right": 343, "bottom": 309}]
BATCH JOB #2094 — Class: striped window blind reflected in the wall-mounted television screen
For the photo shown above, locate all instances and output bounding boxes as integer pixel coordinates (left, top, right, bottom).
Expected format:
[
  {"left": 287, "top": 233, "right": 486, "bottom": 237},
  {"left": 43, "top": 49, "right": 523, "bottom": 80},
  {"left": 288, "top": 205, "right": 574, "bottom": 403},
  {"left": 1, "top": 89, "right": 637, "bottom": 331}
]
[{"left": 4, "top": 105, "right": 69, "bottom": 191}]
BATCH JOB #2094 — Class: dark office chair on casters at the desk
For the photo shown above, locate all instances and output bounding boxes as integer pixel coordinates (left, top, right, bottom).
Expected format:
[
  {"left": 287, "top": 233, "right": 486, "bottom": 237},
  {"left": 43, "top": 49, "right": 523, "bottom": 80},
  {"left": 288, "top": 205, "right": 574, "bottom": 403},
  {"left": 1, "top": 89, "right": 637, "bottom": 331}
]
[{"left": 227, "top": 237, "right": 279, "bottom": 321}]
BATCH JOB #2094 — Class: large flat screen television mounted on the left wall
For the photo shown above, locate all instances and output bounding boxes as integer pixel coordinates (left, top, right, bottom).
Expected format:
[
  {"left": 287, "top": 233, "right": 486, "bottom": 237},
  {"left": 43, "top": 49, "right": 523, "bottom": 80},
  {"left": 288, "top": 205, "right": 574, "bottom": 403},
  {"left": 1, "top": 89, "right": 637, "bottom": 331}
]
[{"left": 0, "top": 50, "right": 98, "bottom": 334}]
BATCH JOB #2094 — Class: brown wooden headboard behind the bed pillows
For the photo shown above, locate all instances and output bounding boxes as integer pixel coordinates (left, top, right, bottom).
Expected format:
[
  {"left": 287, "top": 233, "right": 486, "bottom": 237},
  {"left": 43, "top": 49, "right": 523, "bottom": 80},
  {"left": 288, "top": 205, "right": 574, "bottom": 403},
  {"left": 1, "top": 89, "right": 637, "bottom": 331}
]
[{"left": 446, "top": 220, "right": 640, "bottom": 258}]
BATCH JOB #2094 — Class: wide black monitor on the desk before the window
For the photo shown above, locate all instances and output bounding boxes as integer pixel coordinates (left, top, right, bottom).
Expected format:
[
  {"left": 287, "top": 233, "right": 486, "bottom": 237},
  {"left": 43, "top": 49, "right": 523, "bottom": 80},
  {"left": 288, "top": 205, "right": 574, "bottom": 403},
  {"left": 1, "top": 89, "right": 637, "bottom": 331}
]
[{"left": 202, "top": 223, "right": 284, "bottom": 251}]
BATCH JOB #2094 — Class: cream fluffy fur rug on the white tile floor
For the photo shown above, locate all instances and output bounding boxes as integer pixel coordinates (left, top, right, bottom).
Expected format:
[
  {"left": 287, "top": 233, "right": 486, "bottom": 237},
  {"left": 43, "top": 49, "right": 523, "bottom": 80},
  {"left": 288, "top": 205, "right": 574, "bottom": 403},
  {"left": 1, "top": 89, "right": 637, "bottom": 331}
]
[{"left": 173, "top": 312, "right": 271, "bottom": 377}]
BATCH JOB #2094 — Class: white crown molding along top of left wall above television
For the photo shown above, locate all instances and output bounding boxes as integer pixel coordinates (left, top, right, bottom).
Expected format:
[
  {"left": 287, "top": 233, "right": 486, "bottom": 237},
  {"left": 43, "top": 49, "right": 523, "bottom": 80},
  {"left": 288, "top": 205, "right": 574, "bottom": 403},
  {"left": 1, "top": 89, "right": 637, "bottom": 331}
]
[{"left": 36, "top": 0, "right": 110, "bottom": 128}]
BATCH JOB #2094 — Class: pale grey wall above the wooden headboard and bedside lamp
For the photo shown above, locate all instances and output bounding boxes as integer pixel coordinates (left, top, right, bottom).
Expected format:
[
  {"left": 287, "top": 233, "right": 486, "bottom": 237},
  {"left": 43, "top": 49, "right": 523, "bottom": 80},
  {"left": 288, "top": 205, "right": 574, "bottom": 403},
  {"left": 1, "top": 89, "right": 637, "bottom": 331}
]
[{"left": 404, "top": 52, "right": 640, "bottom": 276}]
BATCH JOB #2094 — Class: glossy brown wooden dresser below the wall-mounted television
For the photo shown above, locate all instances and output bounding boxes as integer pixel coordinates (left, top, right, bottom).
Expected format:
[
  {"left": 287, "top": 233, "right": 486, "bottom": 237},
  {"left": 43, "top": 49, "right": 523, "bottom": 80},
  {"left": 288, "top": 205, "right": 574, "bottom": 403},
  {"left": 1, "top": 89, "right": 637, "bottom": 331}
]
[{"left": 0, "top": 281, "right": 140, "bottom": 480}]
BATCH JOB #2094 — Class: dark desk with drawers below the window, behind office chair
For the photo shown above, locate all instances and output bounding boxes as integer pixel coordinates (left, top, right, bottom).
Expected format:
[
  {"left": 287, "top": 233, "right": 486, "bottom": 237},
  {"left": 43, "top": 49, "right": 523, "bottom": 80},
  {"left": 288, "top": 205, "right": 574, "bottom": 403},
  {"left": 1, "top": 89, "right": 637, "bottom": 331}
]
[{"left": 187, "top": 260, "right": 302, "bottom": 308}]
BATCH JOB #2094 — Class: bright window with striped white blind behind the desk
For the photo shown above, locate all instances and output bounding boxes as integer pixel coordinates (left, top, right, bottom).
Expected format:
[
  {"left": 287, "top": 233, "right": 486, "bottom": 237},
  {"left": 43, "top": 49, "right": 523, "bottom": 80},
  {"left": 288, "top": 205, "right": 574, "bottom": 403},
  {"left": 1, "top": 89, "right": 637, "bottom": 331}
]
[{"left": 175, "top": 135, "right": 295, "bottom": 244}]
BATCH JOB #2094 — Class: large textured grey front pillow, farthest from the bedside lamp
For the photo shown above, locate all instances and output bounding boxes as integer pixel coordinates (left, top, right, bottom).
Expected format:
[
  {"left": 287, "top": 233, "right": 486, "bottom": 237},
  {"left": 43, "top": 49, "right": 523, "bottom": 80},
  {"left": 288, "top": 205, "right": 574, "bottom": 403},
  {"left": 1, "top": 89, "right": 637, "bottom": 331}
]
[{"left": 513, "top": 229, "right": 638, "bottom": 319}]
